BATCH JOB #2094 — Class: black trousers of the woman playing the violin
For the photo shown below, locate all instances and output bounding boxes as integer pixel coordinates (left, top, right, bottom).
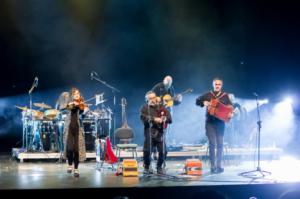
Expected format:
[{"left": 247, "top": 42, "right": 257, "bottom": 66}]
[{"left": 66, "top": 126, "right": 79, "bottom": 169}]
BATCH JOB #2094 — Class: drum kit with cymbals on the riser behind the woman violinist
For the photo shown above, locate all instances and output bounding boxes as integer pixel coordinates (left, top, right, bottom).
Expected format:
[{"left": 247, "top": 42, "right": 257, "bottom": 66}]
[{"left": 15, "top": 95, "right": 113, "bottom": 152}]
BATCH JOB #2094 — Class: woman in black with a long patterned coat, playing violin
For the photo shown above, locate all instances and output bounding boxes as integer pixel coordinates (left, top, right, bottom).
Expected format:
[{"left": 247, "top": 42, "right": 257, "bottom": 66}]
[{"left": 64, "top": 88, "right": 88, "bottom": 177}]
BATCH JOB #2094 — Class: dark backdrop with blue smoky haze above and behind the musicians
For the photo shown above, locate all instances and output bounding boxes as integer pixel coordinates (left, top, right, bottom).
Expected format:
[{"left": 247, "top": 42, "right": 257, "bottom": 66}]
[{"left": 0, "top": 0, "right": 300, "bottom": 151}]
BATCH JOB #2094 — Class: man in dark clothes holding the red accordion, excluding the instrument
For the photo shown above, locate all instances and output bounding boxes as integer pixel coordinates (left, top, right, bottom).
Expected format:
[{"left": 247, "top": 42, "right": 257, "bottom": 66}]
[{"left": 196, "top": 78, "right": 232, "bottom": 173}]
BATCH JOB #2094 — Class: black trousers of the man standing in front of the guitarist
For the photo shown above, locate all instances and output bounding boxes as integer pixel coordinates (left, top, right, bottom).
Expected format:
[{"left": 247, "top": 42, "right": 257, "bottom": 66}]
[{"left": 143, "top": 130, "right": 166, "bottom": 168}]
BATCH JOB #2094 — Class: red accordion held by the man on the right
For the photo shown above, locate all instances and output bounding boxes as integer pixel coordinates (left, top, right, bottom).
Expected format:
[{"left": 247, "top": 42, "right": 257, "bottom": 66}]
[{"left": 207, "top": 99, "right": 233, "bottom": 122}]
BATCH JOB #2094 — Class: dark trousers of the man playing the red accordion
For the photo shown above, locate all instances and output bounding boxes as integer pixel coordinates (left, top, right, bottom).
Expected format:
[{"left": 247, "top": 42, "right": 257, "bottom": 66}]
[{"left": 205, "top": 122, "right": 225, "bottom": 168}]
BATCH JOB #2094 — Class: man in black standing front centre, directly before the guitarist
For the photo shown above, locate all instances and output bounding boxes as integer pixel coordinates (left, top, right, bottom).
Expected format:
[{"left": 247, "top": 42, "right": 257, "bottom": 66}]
[{"left": 140, "top": 91, "right": 172, "bottom": 174}]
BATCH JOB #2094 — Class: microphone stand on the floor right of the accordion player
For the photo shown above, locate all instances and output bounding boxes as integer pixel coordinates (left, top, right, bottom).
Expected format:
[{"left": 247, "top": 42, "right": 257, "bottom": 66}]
[{"left": 239, "top": 93, "right": 271, "bottom": 179}]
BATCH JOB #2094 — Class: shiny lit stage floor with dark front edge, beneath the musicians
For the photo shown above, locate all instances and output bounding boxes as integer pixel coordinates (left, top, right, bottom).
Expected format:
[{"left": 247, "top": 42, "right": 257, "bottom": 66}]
[{"left": 0, "top": 147, "right": 300, "bottom": 198}]
